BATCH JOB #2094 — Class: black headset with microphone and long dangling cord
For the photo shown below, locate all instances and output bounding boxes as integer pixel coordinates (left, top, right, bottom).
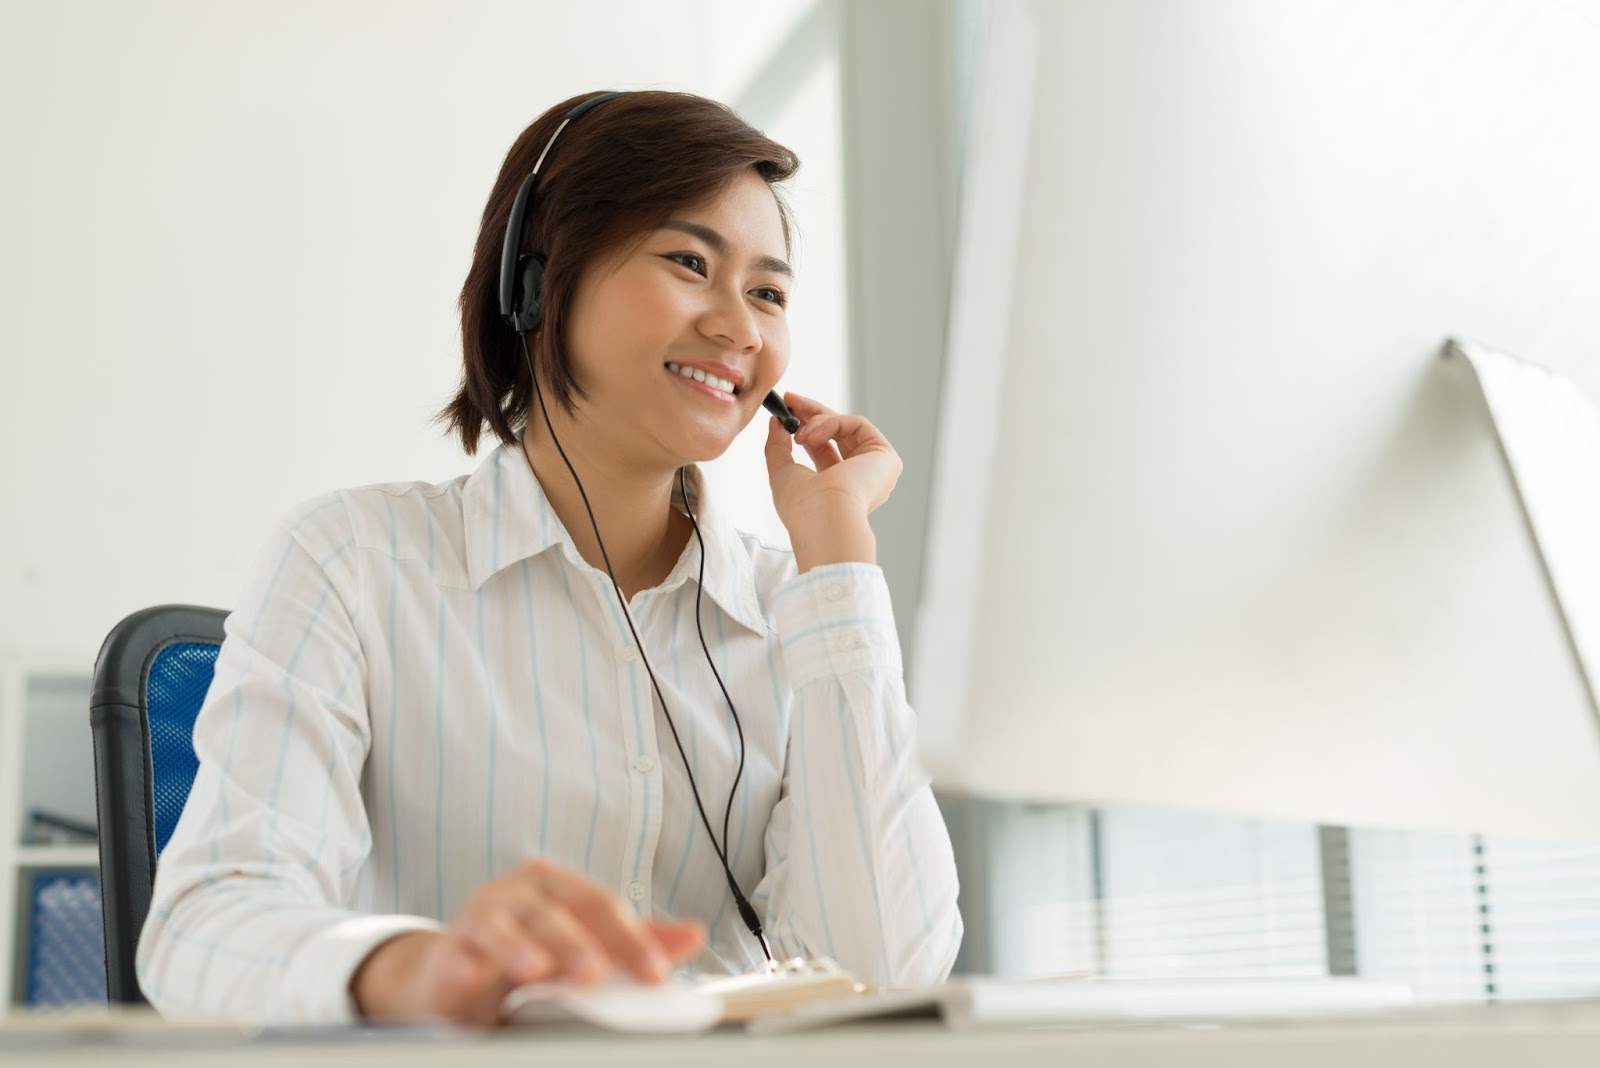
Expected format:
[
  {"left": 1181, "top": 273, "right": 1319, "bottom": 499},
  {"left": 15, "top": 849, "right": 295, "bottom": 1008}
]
[{"left": 499, "top": 93, "right": 800, "bottom": 966}]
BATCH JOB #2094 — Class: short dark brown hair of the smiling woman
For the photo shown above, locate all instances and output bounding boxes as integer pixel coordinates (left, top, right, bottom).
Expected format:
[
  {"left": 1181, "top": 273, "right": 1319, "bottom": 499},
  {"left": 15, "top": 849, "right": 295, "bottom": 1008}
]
[{"left": 438, "top": 91, "right": 800, "bottom": 454}]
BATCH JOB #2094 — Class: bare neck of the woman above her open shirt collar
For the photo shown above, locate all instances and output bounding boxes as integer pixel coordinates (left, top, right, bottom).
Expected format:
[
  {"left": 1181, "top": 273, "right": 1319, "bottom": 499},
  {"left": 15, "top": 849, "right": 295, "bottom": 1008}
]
[{"left": 522, "top": 412, "right": 691, "bottom": 600}]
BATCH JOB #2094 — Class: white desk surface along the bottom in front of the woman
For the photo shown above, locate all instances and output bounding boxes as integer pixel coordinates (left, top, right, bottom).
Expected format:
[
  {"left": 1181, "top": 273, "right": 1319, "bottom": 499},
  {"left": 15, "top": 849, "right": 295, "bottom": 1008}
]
[{"left": 0, "top": 1002, "right": 1600, "bottom": 1068}]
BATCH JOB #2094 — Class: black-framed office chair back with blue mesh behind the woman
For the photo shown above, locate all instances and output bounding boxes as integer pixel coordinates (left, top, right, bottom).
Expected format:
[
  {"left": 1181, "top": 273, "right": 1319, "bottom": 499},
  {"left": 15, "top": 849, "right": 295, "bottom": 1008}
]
[{"left": 90, "top": 604, "right": 227, "bottom": 1004}]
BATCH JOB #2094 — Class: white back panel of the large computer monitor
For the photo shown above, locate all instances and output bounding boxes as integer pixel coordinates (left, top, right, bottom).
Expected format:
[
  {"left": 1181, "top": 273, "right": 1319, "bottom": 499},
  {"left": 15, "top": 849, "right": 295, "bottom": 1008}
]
[{"left": 909, "top": 2, "right": 1600, "bottom": 839}]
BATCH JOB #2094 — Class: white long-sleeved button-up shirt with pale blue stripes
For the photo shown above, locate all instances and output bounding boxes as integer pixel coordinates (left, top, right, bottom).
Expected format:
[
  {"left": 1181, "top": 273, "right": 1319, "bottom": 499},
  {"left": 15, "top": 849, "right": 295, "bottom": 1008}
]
[{"left": 138, "top": 446, "right": 962, "bottom": 1022}]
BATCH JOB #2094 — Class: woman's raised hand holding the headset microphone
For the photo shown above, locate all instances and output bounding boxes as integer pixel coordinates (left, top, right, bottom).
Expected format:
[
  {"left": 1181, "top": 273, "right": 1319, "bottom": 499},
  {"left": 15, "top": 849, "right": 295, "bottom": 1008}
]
[{"left": 766, "top": 393, "right": 904, "bottom": 572}]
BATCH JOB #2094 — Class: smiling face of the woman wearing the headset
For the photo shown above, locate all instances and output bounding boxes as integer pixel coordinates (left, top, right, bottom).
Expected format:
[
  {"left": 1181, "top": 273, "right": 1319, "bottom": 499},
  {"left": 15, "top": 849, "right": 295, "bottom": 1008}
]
[{"left": 566, "top": 171, "right": 792, "bottom": 467}]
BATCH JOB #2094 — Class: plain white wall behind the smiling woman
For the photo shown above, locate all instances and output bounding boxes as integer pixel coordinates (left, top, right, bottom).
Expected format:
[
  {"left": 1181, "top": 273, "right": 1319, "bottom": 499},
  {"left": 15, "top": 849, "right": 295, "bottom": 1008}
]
[{"left": 0, "top": 0, "right": 845, "bottom": 667}]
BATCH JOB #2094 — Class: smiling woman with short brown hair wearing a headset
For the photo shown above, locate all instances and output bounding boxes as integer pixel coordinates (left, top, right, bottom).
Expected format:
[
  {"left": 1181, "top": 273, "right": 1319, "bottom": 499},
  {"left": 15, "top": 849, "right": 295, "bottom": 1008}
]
[{"left": 139, "top": 93, "right": 962, "bottom": 1023}]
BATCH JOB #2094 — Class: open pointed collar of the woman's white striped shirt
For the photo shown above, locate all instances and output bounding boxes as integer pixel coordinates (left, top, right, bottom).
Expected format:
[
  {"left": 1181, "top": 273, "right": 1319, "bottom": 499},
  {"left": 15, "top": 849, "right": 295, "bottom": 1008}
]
[{"left": 461, "top": 443, "right": 766, "bottom": 635}]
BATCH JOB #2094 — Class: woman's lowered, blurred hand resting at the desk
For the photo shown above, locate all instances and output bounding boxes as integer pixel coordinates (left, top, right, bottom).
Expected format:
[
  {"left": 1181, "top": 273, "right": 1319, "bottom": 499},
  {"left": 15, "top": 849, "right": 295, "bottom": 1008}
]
[{"left": 350, "top": 860, "right": 706, "bottom": 1026}]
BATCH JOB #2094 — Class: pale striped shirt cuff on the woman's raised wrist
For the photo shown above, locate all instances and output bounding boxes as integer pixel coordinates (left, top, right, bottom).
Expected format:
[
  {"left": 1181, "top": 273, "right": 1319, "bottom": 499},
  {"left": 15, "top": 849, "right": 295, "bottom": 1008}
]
[{"left": 773, "top": 563, "right": 901, "bottom": 689}]
